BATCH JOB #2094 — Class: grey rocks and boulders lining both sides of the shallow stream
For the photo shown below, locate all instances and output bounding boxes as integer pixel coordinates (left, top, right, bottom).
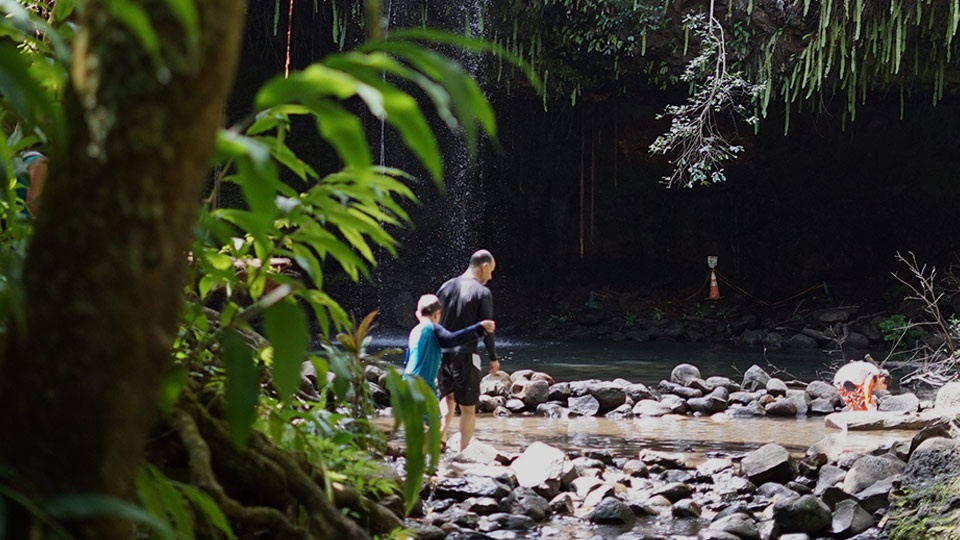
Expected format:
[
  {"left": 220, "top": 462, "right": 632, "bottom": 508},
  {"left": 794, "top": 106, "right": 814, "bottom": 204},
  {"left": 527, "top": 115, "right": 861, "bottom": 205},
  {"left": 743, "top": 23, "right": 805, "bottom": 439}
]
[{"left": 368, "top": 364, "right": 960, "bottom": 540}]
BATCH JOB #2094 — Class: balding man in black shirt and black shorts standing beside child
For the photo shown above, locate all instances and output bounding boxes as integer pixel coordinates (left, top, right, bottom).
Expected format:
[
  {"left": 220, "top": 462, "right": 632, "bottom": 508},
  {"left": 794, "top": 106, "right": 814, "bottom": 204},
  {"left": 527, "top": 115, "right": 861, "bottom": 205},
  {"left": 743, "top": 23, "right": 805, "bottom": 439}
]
[{"left": 437, "top": 249, "right": 500, "bottom": 452}]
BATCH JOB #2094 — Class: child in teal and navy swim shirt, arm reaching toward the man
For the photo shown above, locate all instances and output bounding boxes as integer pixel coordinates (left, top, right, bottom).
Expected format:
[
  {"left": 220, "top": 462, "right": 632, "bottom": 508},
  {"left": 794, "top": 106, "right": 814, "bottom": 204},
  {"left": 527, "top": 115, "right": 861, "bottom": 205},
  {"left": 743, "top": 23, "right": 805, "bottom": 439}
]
[{"left": 403, "top": 294, "right": 496, "bottom": 392}]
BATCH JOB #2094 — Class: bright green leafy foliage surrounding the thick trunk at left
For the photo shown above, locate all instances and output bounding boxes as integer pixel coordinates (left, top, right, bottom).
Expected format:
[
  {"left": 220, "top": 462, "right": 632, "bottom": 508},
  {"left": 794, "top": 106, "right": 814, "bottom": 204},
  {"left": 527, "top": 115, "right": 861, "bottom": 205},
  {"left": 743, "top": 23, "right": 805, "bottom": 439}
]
[{"left": 0, "top": 0, "right": 524, "bottom": 537}]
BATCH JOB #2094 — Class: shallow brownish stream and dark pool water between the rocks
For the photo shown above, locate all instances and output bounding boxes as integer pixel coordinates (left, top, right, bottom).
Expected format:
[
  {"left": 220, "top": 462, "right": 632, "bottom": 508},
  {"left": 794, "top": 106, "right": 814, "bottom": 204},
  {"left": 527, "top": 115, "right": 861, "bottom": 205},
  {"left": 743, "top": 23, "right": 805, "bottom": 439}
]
[{"left": 373, "top": 336, "right": 913, "bottom": 538}]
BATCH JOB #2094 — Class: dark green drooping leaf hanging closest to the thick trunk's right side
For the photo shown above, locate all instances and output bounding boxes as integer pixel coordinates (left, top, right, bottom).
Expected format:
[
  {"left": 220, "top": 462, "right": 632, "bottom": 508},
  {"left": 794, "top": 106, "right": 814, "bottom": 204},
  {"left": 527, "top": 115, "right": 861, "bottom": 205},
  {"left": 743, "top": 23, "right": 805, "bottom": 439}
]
[{"left": 222, "top": 330, "right": 260, "bottom": 446}]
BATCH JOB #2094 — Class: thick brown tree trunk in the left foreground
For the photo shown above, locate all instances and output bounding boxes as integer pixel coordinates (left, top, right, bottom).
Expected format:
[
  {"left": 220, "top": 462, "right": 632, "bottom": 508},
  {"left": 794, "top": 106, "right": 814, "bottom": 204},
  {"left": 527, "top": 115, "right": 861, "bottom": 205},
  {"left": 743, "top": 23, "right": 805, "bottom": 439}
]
[{"left": 0, "top": 0, "right": 246, "bottom": 538}]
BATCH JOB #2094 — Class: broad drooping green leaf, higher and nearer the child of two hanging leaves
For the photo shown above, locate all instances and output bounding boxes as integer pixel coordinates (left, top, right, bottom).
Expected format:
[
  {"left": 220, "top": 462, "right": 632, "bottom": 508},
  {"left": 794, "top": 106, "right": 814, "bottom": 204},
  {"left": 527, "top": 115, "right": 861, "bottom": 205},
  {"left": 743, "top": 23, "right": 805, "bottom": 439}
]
[{"left": 263, "top": 298, "right": 309, "bottom": 400}]
